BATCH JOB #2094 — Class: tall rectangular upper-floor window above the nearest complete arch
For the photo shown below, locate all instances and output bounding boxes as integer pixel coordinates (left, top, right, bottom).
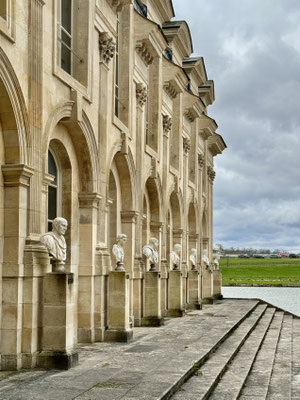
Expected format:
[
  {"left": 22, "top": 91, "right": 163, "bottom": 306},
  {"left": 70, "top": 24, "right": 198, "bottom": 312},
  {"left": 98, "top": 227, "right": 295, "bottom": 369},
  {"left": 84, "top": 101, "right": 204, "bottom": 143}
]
[{"left": 58, "top": 0, "right": 73, "bottom": 75}]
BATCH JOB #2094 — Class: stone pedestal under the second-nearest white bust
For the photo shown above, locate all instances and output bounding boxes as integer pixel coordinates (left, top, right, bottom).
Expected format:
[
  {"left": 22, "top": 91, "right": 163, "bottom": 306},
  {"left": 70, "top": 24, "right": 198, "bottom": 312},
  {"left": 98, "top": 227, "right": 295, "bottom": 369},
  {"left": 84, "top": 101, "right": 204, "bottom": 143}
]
[{"left": 104, "top": 271, "right": 133, "bottom": 342}]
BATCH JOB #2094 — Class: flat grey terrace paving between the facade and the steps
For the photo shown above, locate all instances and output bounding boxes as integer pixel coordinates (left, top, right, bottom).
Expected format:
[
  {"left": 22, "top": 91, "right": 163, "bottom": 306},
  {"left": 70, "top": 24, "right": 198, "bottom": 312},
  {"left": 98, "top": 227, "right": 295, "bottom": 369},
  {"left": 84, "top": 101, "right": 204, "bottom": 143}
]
[{"left": 0, "top": 300, "right": 258, "bottom": 400}]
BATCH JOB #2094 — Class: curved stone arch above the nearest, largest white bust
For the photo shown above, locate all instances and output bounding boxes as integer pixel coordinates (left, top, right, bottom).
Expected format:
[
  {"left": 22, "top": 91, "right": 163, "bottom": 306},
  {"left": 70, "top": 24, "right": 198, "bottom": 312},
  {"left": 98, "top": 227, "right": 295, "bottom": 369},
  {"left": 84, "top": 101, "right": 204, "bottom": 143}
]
[{"left": 43, "top": 101, "right": 100, "bottom": 193}]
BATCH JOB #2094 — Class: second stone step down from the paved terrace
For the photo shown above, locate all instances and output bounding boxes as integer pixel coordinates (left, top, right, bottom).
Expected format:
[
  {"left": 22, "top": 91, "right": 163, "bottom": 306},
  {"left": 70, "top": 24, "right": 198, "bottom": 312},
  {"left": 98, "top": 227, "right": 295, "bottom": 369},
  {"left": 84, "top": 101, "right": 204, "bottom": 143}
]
[{"left": 209, "top": 307, "right": 275, "bottom": 400}]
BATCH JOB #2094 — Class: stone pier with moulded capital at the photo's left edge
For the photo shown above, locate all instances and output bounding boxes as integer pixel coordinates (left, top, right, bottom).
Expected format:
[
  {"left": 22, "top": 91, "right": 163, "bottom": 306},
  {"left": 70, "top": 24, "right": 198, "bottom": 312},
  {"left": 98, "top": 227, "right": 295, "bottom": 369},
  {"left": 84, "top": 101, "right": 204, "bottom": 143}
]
[{"left": 0, "top": 164, "right": 33, "bottom": 370}]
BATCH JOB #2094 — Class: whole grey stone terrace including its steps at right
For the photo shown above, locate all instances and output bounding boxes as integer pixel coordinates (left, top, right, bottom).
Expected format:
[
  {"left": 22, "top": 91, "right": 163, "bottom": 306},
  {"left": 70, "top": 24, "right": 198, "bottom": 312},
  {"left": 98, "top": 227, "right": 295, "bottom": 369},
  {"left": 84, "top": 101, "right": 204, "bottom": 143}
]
[{"left": 0, "top": 300, "right": 300, "bottom": 400}]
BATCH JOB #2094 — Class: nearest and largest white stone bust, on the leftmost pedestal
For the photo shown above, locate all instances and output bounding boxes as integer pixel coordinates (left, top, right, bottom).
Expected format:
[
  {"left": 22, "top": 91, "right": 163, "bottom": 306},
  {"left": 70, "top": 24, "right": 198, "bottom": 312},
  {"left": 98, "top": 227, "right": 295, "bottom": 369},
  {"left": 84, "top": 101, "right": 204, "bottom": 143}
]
[{"left": 40, "top": 218, "right": 68, "bottom": 272}]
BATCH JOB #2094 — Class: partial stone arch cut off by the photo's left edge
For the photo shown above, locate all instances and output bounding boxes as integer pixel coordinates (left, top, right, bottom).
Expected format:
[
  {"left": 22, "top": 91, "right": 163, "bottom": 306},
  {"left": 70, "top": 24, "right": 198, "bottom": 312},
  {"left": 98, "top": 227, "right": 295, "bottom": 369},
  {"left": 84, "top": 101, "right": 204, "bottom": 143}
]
[{"left": 0, "top": 48, "right": 31, "bottom": 165}]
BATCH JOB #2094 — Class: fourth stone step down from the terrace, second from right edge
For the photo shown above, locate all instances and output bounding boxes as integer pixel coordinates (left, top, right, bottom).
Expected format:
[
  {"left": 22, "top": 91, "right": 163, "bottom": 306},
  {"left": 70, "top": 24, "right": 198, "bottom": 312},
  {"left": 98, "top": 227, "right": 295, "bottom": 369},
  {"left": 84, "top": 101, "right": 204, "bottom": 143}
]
[{"left": 266, "top": 314, "right": 293, "bottom": 400}]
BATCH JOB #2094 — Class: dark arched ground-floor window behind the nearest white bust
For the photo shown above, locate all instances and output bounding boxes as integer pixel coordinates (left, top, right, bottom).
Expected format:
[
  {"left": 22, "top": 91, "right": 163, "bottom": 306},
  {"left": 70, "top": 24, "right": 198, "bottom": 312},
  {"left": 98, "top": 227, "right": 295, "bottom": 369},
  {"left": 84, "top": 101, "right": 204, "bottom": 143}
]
[{"left": 48, "top": 151, "right": 58, "bottom": 231}]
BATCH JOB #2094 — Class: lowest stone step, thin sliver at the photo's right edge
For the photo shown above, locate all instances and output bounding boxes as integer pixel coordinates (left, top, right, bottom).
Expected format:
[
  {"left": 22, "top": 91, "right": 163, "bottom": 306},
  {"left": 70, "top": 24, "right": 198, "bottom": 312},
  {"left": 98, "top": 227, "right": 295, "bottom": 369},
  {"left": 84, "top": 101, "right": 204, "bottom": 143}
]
[{"left": 292, "top": 317, "right": 300, "bottom": 400}]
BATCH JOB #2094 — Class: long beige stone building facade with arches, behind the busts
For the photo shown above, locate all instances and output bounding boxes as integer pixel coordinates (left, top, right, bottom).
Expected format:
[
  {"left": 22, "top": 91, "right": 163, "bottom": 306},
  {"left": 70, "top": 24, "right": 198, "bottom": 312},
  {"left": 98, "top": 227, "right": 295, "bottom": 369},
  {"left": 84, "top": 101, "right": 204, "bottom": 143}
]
[{"left": 0, "top": 0, "right": 226, "bottom": 370}]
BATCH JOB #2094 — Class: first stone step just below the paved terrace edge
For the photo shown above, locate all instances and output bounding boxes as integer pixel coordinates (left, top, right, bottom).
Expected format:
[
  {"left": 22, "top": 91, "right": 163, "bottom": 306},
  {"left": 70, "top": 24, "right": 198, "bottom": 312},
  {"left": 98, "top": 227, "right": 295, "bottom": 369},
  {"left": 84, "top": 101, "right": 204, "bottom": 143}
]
[{"left": 172, "top": 304, "right": 267, "bottom": 400}]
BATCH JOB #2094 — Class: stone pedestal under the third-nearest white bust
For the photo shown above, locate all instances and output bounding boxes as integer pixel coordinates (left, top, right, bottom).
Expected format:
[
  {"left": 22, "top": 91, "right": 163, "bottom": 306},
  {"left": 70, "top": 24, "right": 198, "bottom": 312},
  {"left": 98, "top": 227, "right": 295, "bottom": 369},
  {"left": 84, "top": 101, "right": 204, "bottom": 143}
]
[{"left": 142, "top": 271, "right": 164, "bottom": 326}]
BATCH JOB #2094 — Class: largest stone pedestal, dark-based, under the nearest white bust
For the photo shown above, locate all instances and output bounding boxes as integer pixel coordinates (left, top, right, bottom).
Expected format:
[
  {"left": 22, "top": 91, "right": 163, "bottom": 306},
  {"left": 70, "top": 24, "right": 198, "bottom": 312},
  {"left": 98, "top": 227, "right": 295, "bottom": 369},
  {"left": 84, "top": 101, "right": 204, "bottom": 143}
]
[{"left": 38, "top": 272, "right": 78, "bottom": 369}]
